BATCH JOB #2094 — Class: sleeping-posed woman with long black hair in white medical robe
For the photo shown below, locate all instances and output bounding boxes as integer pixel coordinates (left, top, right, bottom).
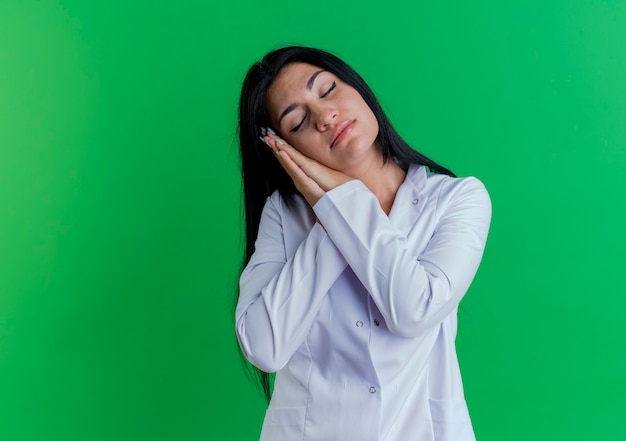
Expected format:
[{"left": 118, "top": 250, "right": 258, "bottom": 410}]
[{"left": 235, "top": 47, "right": 491, "bottom": 441}]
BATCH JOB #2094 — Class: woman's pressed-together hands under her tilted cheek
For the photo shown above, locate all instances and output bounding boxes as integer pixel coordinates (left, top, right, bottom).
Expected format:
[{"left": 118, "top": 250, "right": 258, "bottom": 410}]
[{"left": 261, "top": 129, "right": 352, "bottom": 206}]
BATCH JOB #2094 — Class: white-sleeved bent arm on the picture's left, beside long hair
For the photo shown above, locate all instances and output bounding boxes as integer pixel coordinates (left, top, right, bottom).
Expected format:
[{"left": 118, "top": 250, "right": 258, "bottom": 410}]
[{"left": 235, "top": 193, "right": 346, "bottom": 372}]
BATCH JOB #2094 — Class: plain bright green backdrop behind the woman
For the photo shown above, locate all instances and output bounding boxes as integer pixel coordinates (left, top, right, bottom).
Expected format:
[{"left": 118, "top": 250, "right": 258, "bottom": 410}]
[{"left": 0, "top": 0, "right": 626, "bottom": 441}]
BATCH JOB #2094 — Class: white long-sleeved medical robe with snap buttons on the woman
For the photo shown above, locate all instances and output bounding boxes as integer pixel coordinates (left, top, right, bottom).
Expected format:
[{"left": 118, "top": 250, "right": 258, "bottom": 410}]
[{"left": 236, "top": 166, "right": 491, "bottom": 441}]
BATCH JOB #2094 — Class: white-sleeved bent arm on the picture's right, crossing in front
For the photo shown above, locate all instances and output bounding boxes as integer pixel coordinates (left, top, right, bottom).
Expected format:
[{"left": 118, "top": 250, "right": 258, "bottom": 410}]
[{"left": 314, "top": 178, "right": 491, "bottom": 337}]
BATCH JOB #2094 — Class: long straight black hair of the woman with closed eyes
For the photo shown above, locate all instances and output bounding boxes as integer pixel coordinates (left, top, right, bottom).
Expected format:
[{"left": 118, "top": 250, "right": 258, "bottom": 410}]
[{"left": 237, "top": 46, "right": 454, "bottom": 402}]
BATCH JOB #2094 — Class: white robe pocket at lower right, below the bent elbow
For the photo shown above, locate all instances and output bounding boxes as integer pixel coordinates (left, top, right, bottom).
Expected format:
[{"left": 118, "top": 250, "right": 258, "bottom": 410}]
[{"left": 429, "top": 400, "right": 476, "bottom": 441}]
